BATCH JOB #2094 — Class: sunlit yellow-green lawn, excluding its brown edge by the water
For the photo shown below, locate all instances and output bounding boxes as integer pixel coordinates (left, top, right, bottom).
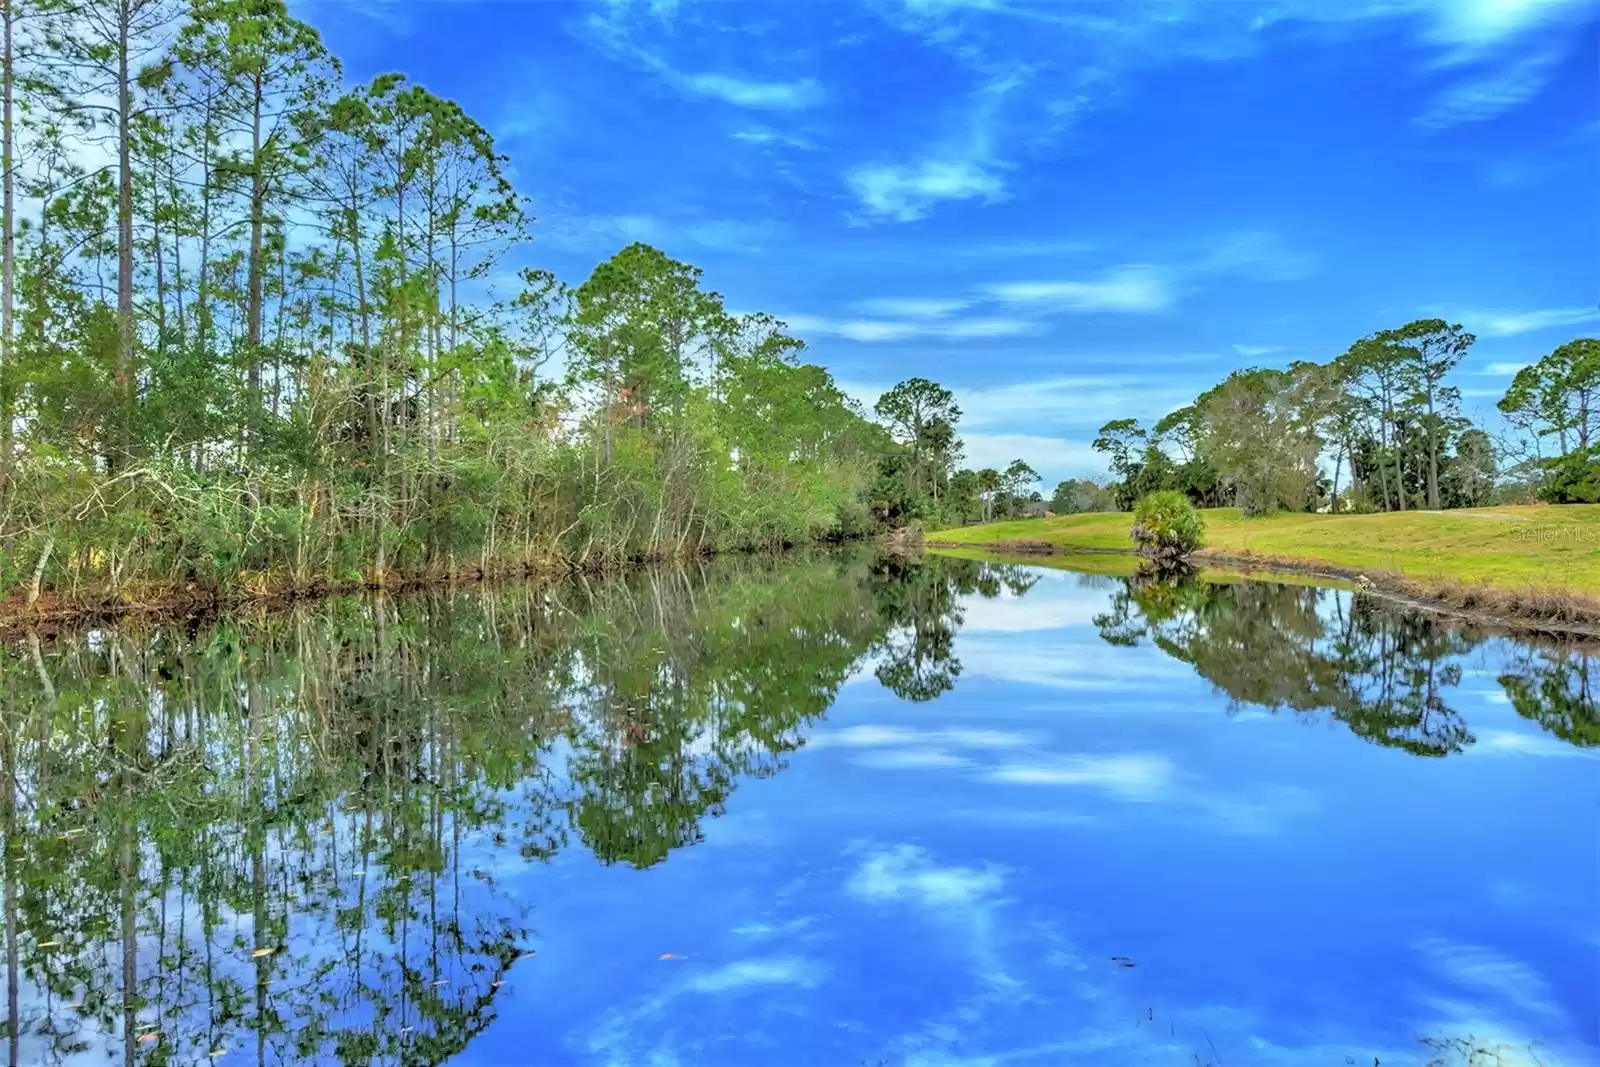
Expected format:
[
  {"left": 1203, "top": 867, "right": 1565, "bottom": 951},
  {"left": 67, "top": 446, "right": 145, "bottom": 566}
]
[{"left": 928, "top": 504, "right": 1600, "bottom": 590}]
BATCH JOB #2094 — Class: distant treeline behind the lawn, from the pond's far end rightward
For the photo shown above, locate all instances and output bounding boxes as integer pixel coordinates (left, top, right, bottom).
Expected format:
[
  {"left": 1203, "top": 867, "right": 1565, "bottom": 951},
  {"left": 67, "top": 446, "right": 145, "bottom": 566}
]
[{"left": 838, "top": 326, "right": 1600, "bottom": 528}]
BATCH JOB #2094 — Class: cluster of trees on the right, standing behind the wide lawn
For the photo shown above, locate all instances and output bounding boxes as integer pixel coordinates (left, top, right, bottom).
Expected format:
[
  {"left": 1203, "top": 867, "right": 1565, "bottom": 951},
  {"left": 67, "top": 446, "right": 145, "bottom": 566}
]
[{"left": 1094, "top": 318, "right": 1600, "bottom": 514}]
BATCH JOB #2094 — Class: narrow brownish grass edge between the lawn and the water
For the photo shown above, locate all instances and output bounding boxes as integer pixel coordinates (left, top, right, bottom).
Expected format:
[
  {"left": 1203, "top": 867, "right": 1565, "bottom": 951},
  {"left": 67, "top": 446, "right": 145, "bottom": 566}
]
[{"left": 923, "top": 539, "right": 1600, "bottom": 637}]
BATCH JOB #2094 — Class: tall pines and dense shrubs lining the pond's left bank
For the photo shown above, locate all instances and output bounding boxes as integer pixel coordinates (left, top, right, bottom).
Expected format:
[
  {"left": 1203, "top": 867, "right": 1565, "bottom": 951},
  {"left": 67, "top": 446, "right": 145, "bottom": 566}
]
[{"left": 0, "top": 0, "right": 922, "bottom": 603}]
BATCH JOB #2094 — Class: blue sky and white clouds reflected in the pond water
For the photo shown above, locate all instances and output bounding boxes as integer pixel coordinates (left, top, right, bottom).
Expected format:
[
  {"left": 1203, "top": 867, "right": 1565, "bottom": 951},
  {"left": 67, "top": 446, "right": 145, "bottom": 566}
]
[{"left": 466, "top": 563, "right": 1600, "bottom": 1067}]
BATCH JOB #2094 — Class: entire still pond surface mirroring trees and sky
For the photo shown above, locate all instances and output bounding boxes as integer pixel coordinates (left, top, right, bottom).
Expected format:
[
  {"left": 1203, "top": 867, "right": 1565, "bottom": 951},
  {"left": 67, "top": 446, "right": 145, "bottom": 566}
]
[{"left": 0, "top": 557, "right": 1600, "bottom": 1067}]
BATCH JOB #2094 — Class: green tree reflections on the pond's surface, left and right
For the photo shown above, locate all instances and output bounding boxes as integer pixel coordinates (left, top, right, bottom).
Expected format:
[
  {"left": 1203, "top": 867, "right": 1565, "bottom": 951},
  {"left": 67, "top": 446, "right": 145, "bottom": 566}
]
[{"left": 0, "top": 555, "right": 1600, "bottom": 1064}]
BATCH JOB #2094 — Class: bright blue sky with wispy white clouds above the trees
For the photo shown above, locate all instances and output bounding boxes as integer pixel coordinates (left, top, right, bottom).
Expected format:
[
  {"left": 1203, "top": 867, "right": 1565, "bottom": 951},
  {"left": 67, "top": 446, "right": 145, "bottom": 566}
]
[{"left": 298, "top": 0, "right": 1600, "bottom": 485}]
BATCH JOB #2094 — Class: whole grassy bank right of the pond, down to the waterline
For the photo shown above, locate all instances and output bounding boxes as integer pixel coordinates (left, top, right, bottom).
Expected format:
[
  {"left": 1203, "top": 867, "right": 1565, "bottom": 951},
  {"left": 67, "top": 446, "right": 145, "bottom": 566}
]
[{"left": 928, "top": 504, "right": 1600, "bottom": 622}]
